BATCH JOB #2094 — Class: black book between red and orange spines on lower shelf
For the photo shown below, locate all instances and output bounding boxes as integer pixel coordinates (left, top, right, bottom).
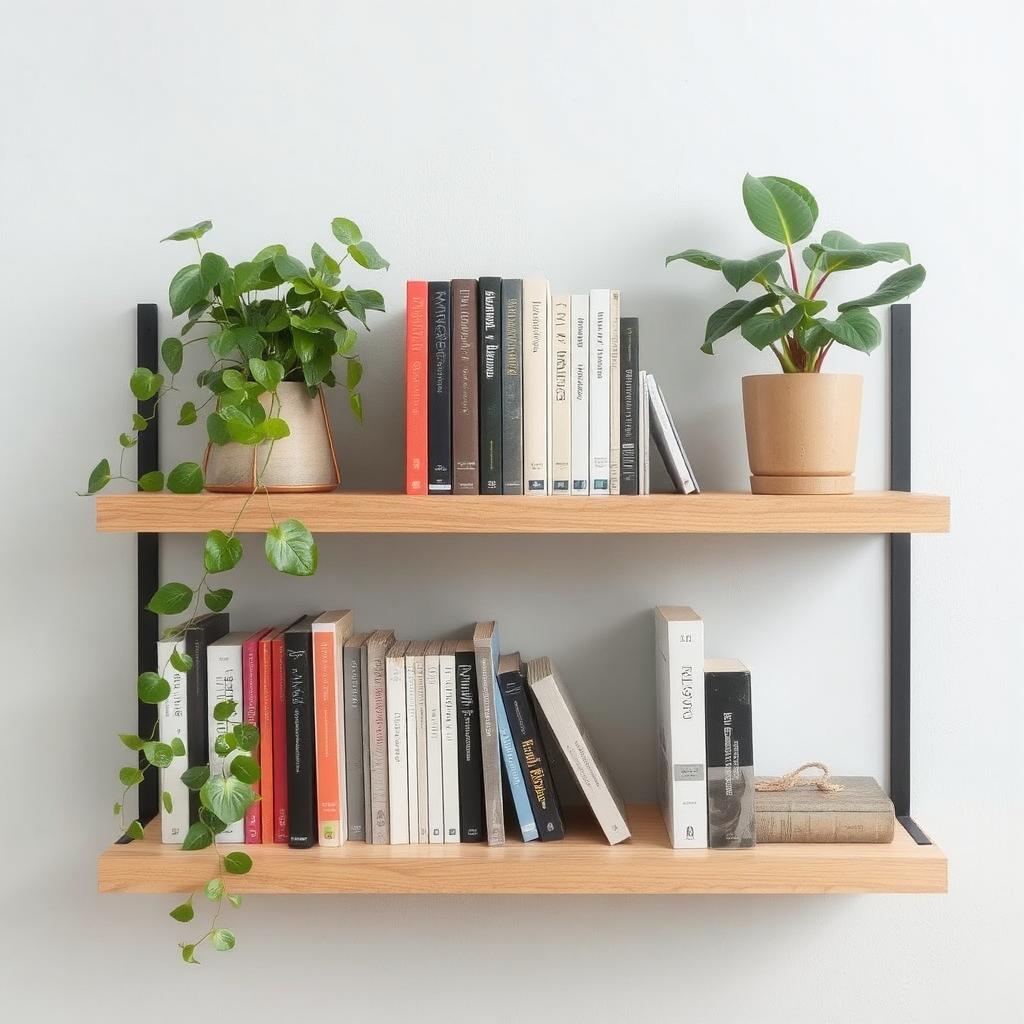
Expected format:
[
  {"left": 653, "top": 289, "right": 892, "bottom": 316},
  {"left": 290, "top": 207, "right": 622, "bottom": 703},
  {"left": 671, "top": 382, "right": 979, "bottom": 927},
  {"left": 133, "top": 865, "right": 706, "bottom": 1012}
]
[{"left": 285, "top": 629, "right": 316, "bottom": 849}]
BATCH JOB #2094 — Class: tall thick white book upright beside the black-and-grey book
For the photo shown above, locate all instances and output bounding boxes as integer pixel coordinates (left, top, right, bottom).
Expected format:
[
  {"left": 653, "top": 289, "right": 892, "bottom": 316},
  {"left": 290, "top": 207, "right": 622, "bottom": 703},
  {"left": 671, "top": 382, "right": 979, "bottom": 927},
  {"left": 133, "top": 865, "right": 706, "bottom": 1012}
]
[{"left": 654, "top": 606, "right": 708, "bottom": 850}]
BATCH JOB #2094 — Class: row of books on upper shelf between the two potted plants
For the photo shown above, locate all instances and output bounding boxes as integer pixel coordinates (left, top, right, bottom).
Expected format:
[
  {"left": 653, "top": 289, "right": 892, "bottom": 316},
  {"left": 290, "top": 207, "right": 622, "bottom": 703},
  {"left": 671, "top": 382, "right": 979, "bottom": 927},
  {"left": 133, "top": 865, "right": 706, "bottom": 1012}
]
[{"left": 406, "top": 278, "right": 697, "bottom": 495}]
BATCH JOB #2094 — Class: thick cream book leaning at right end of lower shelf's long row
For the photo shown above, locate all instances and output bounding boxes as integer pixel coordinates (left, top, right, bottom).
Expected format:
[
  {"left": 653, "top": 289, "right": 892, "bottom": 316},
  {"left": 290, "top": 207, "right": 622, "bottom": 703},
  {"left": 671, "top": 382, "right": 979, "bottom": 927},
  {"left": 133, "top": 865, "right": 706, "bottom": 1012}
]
[{"left": 526, "top": 657, "right": 630, "bottom": 845}]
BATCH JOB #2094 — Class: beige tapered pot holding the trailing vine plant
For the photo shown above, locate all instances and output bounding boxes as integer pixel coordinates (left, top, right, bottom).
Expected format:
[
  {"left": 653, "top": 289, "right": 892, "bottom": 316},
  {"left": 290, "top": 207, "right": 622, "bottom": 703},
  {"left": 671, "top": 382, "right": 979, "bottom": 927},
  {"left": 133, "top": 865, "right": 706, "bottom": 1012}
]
[{"left": 203, "top": 381, "right": 341, "bottom": 493}]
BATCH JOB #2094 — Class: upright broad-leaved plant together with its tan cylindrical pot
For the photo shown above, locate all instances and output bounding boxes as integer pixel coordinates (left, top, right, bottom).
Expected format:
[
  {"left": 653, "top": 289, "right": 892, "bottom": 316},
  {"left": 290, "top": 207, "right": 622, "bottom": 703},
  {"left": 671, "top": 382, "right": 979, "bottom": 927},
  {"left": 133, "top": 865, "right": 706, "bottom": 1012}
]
[{"left": 666, "top": 174, "right": 925, "bottom": 495}]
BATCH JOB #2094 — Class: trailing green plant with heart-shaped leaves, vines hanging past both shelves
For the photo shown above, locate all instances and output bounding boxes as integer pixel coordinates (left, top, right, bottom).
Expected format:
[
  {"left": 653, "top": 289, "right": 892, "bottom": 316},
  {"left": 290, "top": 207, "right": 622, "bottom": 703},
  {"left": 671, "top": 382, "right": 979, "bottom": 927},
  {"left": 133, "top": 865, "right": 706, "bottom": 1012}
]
[{"left": 86, "top": 217, "right": 388, "bottom": 964}]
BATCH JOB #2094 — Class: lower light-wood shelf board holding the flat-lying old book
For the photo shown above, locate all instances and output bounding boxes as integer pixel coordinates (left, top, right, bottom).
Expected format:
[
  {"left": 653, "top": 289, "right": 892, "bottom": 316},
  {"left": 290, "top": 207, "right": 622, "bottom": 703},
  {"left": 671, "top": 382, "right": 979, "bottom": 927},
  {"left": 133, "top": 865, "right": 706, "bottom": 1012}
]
[{"left": 99, "top": 805, "right": 946, "bottom": 894}]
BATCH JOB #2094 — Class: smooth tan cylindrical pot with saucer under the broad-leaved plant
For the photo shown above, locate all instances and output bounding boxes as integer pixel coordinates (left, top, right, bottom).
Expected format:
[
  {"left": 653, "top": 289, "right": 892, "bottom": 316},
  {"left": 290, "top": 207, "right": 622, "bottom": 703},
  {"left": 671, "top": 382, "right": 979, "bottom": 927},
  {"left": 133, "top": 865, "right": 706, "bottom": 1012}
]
[{"left": 743, "top": 374, "right": 863, "bottom": 495}]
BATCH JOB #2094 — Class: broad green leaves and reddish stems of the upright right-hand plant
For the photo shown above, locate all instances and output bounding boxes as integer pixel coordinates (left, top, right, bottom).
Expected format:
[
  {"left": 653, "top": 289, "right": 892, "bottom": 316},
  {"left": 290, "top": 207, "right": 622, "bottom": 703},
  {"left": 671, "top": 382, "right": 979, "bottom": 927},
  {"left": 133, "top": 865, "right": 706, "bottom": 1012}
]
[{"left": 665, "top": 174, "right": 925, "bottom": 374}]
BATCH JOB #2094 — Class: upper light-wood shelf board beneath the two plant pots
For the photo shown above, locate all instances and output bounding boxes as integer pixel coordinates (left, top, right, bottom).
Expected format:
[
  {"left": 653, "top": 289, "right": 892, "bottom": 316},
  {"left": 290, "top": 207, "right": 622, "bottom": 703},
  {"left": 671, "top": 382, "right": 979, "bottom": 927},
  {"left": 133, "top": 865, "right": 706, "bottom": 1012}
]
[{"left": 96, "top": 490, "right": 949, "bottom": 534}]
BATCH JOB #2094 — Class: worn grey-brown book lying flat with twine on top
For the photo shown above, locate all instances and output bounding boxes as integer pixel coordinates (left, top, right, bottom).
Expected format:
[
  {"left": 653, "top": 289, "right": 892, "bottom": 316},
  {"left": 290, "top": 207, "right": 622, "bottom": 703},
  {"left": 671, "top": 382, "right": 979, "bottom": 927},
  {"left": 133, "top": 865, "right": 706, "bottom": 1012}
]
[{"left": 754, "top": 775, "right": 896, "bottom": 843}]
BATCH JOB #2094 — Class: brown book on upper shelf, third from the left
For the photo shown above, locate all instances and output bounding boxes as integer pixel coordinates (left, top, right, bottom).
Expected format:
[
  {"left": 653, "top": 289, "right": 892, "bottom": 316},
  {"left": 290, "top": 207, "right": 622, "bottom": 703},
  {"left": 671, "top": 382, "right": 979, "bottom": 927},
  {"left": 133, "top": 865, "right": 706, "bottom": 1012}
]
[{"left": 452, "top": 278, "right": 480, "bottom": 495}]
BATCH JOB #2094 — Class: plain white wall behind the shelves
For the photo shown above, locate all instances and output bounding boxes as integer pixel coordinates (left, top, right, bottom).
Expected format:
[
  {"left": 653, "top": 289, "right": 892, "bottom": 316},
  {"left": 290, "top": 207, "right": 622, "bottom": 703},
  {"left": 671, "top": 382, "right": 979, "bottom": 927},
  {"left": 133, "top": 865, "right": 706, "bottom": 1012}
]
[{"left": 0, "top": 0, "right": 1024, "bottom": 1024}]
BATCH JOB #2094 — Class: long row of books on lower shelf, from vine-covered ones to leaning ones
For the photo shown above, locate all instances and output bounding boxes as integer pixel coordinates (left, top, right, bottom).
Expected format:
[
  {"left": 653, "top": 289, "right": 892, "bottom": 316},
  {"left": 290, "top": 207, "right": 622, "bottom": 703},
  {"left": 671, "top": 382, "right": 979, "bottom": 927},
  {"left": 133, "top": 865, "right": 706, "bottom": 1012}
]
[{"left": 157, "top": 610, "right": 629, "bottom": 848}]
